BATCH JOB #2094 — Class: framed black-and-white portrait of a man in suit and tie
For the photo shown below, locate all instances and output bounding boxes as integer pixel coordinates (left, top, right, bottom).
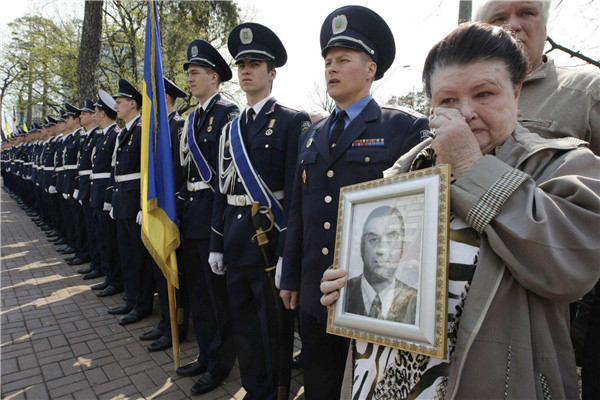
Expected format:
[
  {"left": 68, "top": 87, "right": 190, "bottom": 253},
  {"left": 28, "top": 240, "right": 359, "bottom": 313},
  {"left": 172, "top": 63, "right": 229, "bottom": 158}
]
[{"left": 327, "top": 165, "right": 450, "bottom": 358}]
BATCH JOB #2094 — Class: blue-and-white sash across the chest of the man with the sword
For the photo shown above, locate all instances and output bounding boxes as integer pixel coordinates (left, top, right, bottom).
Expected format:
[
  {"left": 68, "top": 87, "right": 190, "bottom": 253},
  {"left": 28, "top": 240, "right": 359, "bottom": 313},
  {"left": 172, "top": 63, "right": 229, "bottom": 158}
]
[{"left": 229, "top": 116, "right": 283, "bottom": 230}]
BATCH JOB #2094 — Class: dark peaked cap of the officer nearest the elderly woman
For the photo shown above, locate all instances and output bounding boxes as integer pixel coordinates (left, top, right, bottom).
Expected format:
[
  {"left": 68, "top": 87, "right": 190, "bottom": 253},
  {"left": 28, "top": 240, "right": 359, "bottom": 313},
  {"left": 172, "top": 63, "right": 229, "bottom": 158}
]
[{"left": 320, "top": 6, "right": 396, "bottom": 80}]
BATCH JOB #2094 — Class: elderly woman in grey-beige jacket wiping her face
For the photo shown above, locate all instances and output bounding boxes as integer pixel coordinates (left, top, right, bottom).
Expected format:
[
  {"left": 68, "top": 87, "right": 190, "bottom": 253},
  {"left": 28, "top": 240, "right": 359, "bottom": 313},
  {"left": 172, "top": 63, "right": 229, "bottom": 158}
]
[{"left": 321, "top": 24, "right": 600, "bottom": 399}]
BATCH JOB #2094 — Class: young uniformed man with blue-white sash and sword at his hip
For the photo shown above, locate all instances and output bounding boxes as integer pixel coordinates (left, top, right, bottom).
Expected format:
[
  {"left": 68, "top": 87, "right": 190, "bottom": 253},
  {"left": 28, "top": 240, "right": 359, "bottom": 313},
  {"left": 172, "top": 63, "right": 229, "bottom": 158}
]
[{"left": 209, "top": 23, "right": 310, "bottom": 399}]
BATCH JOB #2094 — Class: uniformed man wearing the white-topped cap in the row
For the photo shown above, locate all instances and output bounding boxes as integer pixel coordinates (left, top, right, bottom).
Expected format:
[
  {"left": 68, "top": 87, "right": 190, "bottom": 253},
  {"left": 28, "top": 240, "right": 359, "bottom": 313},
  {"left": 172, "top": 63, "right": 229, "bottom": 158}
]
[{"left": 90, "top": 90, "right": 123, "bottom": 297}]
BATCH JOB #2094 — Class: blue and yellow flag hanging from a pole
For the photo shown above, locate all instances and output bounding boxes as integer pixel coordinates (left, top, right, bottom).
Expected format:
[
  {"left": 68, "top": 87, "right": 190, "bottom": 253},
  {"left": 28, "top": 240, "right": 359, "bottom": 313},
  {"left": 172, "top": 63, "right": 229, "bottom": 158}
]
[{"left": 140, "top": 0, "right": 179, "bottom": 287}]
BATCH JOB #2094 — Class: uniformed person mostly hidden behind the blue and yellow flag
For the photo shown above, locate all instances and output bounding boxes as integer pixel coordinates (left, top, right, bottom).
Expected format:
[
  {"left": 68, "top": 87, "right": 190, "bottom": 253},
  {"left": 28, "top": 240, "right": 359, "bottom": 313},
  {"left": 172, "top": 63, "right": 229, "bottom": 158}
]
[{"left": 140, "top": 77, "right": 188, "bottom": 352}]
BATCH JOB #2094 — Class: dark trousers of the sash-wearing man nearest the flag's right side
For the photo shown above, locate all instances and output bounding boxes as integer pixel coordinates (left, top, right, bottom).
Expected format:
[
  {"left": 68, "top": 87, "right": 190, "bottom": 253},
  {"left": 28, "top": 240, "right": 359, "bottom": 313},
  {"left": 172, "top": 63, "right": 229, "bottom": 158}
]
[{"left": 179, "top": 239, "right": 236, "bottom": 378}]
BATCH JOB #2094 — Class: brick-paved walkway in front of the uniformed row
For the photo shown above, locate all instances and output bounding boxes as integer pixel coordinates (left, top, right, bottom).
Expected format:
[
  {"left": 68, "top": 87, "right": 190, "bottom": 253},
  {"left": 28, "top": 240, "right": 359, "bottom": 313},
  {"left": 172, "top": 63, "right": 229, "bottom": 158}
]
[{"left": 0, "top": 190, "right": 303, "bottom": 400}]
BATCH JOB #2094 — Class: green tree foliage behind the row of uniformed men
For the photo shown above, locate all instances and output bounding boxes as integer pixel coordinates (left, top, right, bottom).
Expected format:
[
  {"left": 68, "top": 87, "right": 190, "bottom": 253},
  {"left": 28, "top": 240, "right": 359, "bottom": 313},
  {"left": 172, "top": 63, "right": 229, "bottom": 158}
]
[{"left": 0, "top": 0, "right": 240, "bottom": 124}]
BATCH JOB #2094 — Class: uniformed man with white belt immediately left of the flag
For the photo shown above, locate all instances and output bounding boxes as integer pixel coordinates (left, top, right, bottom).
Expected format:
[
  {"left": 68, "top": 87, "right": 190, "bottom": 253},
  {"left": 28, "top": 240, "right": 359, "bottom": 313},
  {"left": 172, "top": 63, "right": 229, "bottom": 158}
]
[{"left": 105, "top": 78, "right": 154, "bottom": 325}]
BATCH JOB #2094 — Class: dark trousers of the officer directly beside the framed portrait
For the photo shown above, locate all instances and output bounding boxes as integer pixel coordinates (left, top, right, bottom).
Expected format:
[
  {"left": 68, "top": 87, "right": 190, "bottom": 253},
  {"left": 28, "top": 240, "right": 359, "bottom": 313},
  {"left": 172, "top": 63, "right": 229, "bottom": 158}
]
[{"left": 300, "top": 310, "right": 350, "bottom": 400}]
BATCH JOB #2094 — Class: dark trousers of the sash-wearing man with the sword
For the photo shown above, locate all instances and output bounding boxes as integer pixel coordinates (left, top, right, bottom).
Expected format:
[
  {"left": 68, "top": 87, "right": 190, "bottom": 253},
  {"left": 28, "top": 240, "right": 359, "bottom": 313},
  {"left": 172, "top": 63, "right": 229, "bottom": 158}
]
[{"left": 227, "top": 266, "right": 278, "bottom": 399}]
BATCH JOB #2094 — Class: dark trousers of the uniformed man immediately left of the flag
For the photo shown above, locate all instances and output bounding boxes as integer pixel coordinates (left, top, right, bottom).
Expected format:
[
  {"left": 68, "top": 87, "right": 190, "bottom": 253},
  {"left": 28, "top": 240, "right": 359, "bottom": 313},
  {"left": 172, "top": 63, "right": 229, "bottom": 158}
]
[{"left": 117, "top": 218, "right": 154, "bottom": 315}]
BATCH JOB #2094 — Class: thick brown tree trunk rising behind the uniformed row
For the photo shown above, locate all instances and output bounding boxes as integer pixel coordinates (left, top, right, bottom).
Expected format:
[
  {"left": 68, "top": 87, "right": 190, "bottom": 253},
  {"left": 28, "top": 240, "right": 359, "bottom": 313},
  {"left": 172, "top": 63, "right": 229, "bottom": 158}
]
[{"left": 77, "top": 0, "right": 104, "bottom": 104}]
